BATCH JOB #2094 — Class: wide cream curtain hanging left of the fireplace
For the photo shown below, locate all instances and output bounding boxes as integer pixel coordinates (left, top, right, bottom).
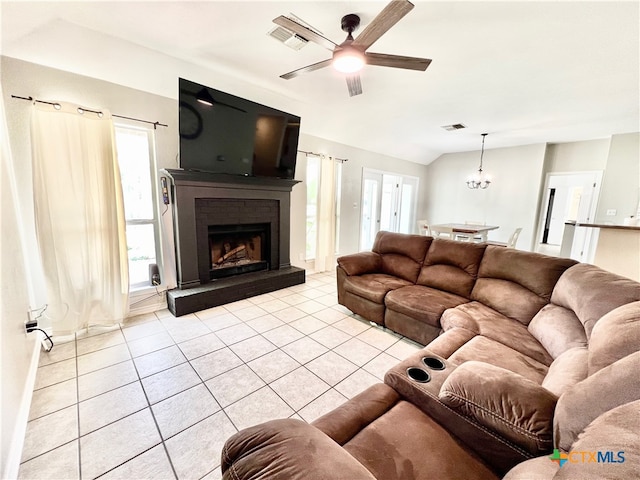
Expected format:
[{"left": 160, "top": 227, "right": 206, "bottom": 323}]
[{"left": 31, "top": 103, "right": 129, "bottom": 335}]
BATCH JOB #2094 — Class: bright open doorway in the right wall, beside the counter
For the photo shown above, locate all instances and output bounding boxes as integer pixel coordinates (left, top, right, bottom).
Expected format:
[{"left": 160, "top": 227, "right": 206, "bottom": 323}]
[{"left": 536, "top": 171, "right": 602, "bottom": 262}]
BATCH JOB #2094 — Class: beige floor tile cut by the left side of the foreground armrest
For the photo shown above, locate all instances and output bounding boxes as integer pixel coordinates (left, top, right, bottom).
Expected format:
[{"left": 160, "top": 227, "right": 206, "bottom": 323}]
[{"left": 166, "top": 411, "right": 237, "bottom": 479}]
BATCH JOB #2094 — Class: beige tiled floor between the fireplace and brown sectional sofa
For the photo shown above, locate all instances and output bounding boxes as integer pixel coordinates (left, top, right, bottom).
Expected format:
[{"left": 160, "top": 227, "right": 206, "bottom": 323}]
[{"left": 19, "top": 274, "right": 419, "bottom": 479}]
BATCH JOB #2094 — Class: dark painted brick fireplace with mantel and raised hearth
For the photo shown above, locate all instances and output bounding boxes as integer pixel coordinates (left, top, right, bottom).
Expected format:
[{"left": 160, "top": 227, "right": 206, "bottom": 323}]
[{"left": 162, "top": 170, "right": 305, "bottom": 316}]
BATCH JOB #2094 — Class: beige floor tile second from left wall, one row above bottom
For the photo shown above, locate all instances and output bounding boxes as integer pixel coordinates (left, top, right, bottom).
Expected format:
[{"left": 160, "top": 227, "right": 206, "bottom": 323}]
[{"left": 78, "top": 382, "right": 148, "bottom": 435}]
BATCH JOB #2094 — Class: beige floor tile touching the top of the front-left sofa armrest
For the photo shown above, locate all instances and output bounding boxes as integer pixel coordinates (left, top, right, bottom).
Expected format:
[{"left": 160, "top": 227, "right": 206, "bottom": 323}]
[{"left": 225, "top": 387, "right": 295, "bottom": 430}]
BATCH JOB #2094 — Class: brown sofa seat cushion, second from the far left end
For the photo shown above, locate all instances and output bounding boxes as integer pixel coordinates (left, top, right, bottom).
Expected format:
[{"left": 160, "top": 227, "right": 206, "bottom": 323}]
[{"left": 384, "top": 285, "right": 469, "bottom": 328}]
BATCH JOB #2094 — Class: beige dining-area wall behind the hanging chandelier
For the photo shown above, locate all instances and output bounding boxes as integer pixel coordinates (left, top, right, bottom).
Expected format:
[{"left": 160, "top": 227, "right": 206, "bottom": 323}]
[{"left": 425, "top": 144, "right": 545, "bottom": 250}]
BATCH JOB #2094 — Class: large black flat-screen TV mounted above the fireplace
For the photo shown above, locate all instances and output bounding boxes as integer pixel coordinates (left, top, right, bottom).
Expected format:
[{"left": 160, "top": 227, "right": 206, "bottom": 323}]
[{"left": 178, "top": 78, "right": 300, "bottom": 179}]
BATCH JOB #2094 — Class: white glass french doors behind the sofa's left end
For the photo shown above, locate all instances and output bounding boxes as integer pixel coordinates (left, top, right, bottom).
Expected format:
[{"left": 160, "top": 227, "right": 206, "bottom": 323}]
[{"left": 360, "top": 168, "right": 418, "bottom": 251}]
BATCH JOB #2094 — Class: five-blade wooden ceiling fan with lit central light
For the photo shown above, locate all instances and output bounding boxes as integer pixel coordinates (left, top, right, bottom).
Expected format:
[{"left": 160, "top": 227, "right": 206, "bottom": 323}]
[{"left": 273, "top": 0, "right": 431, "bottom": 97}]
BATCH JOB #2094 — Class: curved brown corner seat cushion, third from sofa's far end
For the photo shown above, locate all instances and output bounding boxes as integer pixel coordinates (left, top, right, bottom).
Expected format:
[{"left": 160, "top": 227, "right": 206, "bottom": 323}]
[{"left": 441, "top": 302, "right": 553, "bottom": 365}]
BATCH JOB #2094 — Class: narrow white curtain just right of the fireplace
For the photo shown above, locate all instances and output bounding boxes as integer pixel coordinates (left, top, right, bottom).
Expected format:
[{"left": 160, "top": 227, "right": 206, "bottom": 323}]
[{"left": 314, "top": 155, "right": 338, "bottom": 272}]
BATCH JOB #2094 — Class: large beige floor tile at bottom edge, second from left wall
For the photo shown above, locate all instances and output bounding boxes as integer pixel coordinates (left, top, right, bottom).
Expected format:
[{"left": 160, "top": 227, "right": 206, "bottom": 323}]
[{"left": 80, "top": 408, "right": 160, "bottom": 478}]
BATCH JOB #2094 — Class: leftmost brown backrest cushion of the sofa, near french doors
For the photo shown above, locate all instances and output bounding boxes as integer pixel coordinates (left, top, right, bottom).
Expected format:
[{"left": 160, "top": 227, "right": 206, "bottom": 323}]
[{"left": 372, "top": 231, "right": 432, "bottom": 283}]
